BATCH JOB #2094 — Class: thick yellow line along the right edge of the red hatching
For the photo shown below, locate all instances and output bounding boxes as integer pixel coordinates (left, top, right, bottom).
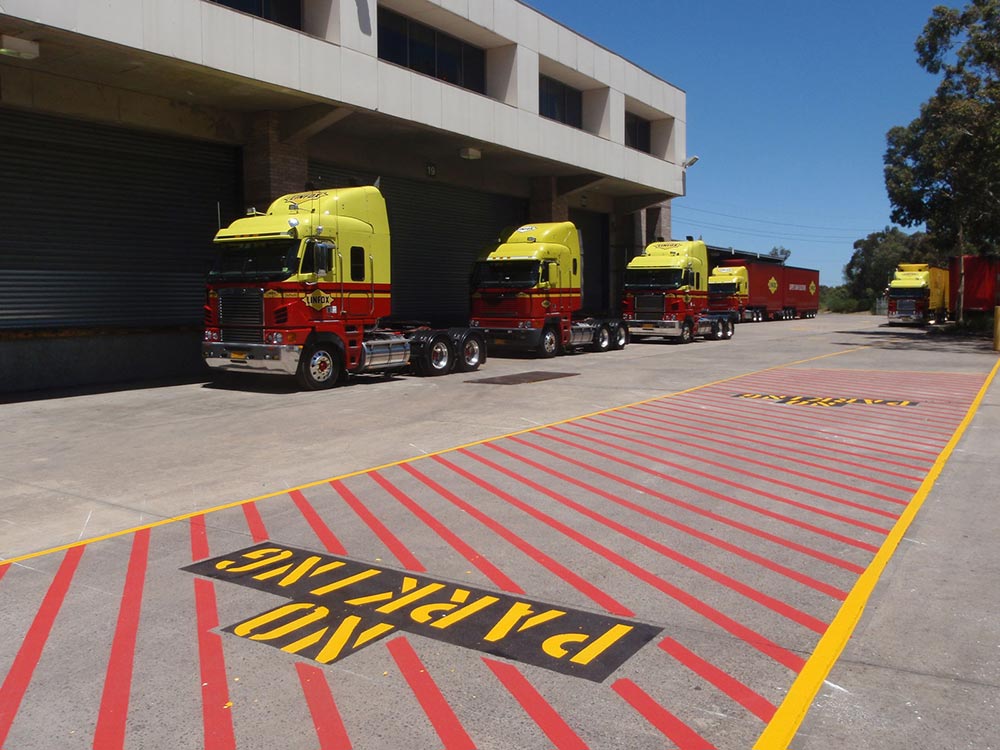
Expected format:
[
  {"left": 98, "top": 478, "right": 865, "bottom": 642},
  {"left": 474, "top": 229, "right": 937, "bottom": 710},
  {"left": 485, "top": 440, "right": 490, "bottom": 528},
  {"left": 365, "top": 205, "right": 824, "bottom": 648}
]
[{"left": 753, "top": 360, "right": 1000, "bottom": 750}]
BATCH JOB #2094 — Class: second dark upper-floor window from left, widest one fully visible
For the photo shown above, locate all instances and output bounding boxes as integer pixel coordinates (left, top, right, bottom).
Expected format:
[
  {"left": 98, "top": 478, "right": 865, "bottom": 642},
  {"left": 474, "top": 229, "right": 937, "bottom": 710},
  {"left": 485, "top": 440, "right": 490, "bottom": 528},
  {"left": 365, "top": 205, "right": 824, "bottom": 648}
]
[{"left": 378, "top": 8, "right": 486, "bottom": 94}]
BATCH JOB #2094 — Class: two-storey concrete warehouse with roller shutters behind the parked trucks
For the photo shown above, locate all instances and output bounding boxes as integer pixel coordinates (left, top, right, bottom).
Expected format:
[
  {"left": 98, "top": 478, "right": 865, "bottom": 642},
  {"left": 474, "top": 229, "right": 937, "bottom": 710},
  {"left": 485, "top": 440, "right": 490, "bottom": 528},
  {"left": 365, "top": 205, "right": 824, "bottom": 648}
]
[{"left": 0, "top": 0, "right": 686, "bottom": 392}]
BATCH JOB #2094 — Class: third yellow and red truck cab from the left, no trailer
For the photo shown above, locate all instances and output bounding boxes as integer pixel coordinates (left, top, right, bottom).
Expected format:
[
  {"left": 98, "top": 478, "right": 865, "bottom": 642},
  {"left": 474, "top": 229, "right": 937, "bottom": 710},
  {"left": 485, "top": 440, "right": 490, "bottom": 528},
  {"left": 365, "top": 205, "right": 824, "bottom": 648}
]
[{"left": 622, "top": 238, "right": 733, "bottom": 343}]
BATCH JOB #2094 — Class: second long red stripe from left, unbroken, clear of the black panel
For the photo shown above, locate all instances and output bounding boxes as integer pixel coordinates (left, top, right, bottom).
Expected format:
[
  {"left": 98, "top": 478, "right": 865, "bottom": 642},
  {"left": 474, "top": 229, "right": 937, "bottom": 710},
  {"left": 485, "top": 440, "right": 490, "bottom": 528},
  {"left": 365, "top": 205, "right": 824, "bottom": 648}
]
[{"left": 94, "top": 529, "right": 150, "bottom": 750}]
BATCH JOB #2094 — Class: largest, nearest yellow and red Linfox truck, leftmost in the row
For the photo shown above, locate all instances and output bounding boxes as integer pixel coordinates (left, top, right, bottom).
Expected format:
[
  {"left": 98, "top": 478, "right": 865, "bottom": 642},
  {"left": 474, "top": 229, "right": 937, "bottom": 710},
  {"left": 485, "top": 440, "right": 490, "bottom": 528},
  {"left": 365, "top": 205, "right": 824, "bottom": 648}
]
[{"left": 202, "top": 187, "right": 486, "bottom": 389}]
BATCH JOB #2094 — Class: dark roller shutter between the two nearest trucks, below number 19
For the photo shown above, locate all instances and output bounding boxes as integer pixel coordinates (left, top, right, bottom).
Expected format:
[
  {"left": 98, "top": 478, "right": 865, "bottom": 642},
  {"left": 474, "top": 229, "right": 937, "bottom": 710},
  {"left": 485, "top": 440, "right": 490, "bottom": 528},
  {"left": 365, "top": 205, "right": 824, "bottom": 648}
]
[{"left": 309, "top": 162, "right": 528, "bottom": 326}]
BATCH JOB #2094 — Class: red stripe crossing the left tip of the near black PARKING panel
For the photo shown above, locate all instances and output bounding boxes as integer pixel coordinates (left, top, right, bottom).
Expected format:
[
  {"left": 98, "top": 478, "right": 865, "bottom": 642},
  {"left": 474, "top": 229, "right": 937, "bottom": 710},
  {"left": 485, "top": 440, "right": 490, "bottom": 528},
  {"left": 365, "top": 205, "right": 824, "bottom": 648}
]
[{"left": 191, "top": 515, "right": 236, "bottom": 750}]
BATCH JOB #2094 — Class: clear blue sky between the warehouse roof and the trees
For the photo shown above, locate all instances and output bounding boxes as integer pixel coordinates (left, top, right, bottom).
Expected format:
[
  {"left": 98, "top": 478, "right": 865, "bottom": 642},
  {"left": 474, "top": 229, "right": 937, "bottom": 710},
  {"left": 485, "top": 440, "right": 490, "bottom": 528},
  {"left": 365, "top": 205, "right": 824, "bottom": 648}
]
[{"left": 526, "top": 0, "right": 944, "bottom": 286}]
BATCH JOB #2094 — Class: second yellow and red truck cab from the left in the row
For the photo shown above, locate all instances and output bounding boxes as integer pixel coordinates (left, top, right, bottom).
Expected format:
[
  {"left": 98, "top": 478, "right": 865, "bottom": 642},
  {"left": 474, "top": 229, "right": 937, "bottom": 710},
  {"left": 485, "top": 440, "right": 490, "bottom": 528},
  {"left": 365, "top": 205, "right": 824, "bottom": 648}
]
[{"left": 470, "top": 221, "right": 628, "bottom": 357}]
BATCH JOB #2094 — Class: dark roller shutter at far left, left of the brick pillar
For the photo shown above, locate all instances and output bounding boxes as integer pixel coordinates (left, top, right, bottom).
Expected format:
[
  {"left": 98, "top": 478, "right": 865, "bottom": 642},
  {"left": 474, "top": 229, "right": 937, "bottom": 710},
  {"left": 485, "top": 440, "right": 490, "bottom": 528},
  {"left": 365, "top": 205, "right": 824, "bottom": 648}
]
[{"left": 0, "top": 110, "right": 241, "bottom": 330}]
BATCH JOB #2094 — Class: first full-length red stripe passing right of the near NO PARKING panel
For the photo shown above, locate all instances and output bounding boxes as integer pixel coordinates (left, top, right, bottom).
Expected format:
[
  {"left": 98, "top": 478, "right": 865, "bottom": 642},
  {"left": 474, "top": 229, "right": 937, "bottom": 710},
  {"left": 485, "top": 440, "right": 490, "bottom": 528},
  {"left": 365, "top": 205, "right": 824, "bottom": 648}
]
[{"left": 434, "top": 451, "right": 805, "bottom": 672}]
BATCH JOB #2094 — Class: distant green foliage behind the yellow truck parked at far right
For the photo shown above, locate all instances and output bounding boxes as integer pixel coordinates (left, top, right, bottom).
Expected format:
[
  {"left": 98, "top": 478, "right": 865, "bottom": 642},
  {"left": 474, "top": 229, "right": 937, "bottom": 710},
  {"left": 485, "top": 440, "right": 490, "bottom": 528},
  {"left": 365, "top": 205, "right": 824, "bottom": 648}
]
[{"left": 844, "top": 227, "right": 947, "bottom": 308}]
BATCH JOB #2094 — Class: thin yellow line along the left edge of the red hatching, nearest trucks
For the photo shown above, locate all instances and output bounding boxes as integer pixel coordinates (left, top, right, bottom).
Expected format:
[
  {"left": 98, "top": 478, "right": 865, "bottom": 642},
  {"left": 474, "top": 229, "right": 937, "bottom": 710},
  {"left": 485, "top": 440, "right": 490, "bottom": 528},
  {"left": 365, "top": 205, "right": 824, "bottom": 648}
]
[{"left": 0, "top": 346, "right": 868, "bottom": 565}]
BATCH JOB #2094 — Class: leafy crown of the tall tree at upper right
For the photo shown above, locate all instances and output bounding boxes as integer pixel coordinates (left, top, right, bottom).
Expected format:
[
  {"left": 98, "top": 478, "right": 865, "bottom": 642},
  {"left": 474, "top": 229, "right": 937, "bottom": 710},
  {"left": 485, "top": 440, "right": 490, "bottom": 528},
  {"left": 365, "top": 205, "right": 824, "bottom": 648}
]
[{"left": 885, "top": 0, "right": 1000, "bottom": 253}]
